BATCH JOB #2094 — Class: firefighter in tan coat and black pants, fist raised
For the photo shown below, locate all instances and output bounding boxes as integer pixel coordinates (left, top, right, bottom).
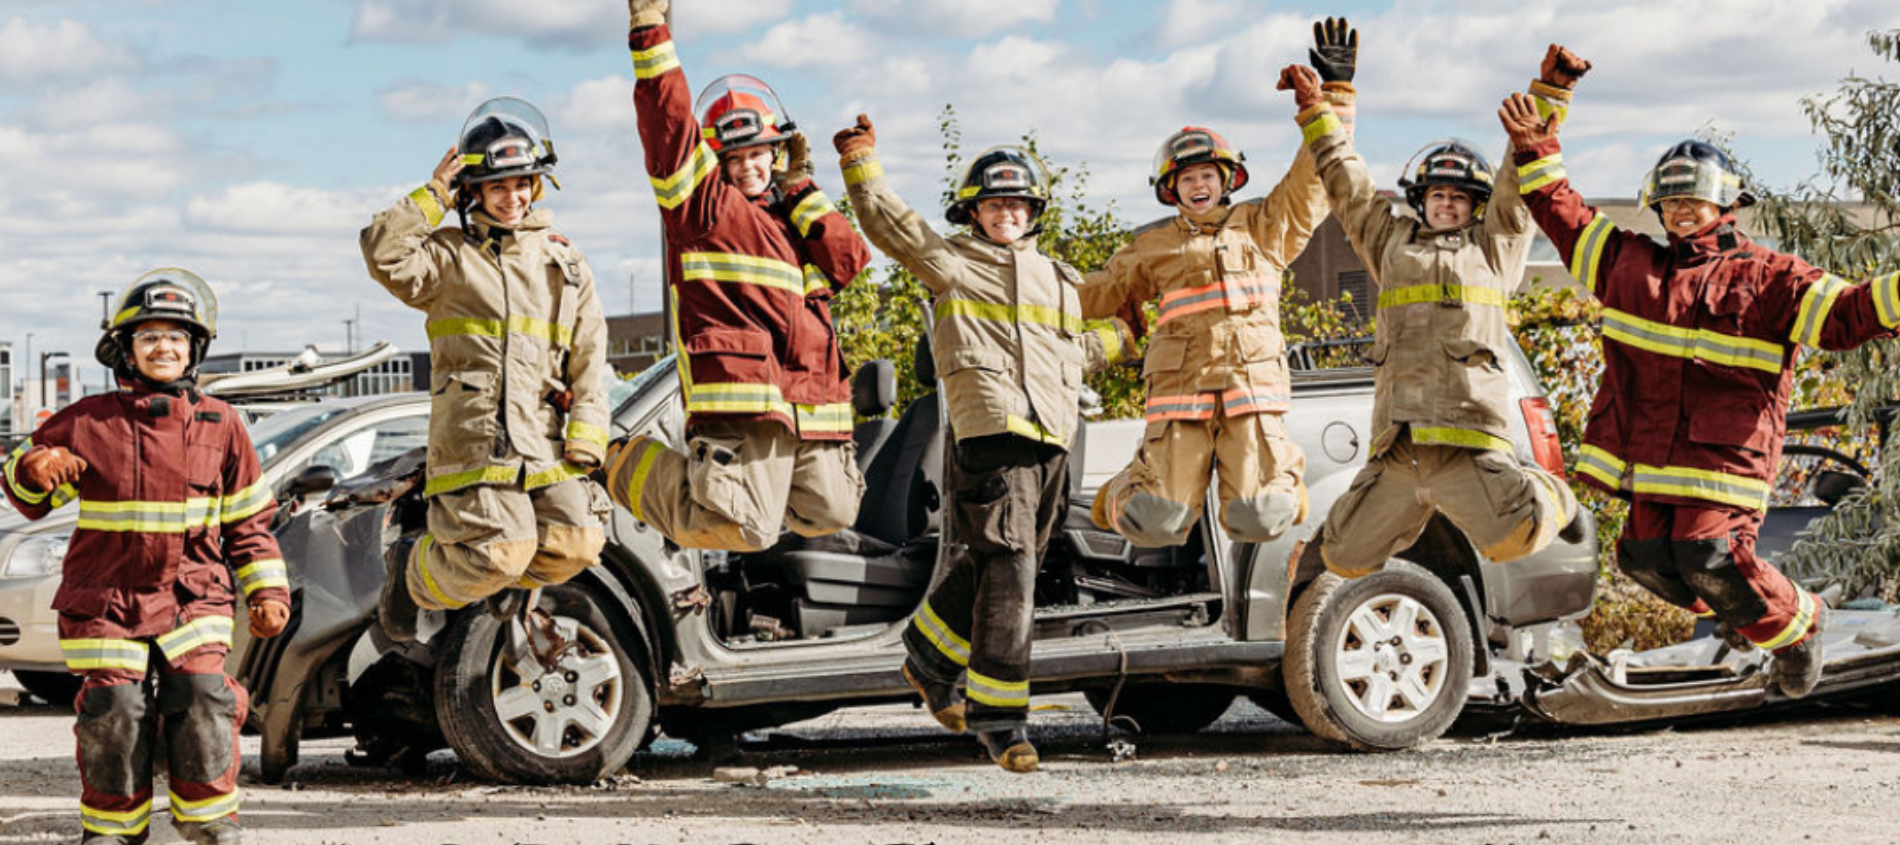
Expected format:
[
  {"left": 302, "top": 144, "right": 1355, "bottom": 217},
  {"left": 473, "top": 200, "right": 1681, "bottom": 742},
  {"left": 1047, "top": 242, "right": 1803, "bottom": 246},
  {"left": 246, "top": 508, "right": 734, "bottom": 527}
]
[{"left": 834, "top": 116, "right": 1134, "bottom": 771}]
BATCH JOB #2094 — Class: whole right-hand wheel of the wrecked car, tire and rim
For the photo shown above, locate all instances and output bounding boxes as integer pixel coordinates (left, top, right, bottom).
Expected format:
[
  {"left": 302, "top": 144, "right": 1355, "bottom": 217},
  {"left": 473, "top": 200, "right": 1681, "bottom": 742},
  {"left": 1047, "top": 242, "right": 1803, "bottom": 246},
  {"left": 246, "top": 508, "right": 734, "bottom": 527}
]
[{"left": 1283, "top": 560, "right": 1473, "bottom": 752}]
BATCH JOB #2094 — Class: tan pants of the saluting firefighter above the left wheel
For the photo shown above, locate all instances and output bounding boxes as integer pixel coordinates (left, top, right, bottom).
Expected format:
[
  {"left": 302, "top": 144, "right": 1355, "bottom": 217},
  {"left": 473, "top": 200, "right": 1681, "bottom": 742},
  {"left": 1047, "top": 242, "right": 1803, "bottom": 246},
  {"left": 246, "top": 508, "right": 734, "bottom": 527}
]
[{"left": 409, "top": 479, "right": 608, "bottom": 610}]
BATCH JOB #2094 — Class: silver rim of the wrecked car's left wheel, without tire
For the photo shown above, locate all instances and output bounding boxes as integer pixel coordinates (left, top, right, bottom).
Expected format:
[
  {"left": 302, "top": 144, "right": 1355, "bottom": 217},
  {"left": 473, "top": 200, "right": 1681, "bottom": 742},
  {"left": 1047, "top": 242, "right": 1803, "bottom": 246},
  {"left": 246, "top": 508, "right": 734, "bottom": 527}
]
[{"left": 488, "top": 617, "right": 625, "bottom": 758}]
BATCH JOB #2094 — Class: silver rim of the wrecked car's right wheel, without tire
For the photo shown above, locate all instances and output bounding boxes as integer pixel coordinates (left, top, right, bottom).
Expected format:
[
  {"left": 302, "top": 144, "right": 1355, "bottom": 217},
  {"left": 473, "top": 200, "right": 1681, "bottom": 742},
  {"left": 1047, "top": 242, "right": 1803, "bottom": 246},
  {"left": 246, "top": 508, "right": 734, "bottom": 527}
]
[{"left": 1334, "top": 594, "right": 1452, "bottom": 723}]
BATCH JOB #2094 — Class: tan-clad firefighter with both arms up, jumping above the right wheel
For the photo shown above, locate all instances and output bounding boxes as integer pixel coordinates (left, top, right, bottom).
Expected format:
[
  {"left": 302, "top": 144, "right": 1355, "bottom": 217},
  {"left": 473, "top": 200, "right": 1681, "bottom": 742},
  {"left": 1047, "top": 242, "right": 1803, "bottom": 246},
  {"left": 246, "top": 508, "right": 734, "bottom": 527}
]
[{"left": 1281, "top": 46, "right": 1588, "bottom": 577}]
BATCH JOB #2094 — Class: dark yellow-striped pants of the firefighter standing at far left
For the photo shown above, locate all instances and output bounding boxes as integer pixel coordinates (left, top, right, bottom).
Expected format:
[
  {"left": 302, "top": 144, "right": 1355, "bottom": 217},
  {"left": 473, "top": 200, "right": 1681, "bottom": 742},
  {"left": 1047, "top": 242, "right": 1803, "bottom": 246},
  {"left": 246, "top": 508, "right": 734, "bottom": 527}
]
[{"left": 59, "top": 600, "right": 249, "bottom": 841}]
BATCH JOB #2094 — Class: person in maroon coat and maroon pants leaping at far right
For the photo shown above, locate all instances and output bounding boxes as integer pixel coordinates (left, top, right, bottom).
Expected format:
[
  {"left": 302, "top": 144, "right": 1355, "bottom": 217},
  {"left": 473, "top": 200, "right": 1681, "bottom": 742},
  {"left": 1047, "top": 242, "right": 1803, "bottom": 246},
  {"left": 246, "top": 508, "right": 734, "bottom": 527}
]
[{"left": 1499, "top": 95, "right": 1900, "bottom": 697}]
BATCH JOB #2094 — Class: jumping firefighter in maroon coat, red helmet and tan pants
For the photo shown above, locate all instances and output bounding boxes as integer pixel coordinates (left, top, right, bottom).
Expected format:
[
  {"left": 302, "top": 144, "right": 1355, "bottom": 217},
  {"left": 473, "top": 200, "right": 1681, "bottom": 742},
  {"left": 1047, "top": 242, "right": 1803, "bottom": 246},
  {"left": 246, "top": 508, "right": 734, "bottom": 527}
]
[{"left": 608, "top": 0, "right": 870, "bottom": 551}]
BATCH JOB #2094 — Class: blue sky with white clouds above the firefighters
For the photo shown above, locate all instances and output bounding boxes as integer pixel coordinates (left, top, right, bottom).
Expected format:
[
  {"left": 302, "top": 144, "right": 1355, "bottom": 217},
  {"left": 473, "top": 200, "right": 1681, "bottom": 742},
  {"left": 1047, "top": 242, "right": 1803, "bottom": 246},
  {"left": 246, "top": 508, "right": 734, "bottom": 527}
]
[{"left": 0, "top": 0, "right": 1900, "bottom": 389}]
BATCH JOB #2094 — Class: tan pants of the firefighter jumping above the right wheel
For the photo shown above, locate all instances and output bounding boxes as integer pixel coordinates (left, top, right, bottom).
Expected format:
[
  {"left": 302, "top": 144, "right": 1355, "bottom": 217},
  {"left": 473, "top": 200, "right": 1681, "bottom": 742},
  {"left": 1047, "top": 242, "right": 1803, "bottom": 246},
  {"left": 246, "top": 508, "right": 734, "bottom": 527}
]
[{"left": 1321, "top": 437, "right": 1577, "bottom": 577}]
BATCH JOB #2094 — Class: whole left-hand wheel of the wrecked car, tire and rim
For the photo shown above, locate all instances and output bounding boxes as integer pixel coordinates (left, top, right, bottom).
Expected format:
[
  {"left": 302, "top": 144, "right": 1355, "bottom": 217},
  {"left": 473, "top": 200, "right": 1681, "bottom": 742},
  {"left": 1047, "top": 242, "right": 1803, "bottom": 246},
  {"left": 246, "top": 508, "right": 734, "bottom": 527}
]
[{"left": 435, "top": 583, "right": 654, "bottom": 784}]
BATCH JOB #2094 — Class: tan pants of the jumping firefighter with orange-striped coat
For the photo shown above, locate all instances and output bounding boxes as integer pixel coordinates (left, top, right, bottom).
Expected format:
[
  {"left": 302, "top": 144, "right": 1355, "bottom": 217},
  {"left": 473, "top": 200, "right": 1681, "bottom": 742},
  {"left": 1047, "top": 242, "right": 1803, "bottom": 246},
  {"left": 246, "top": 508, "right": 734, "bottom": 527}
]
[{"left": 1091, "top": 412, "right": 1307, "bottom": 547}]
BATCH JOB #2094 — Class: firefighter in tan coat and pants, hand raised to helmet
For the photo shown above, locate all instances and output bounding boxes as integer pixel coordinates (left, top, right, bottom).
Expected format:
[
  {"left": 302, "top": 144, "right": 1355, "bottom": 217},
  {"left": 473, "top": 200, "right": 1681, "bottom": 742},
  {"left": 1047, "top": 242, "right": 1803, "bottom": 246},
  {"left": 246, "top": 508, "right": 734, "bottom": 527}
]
[{"left": 363, "top": 99, "right": 610, "bottom": 640}]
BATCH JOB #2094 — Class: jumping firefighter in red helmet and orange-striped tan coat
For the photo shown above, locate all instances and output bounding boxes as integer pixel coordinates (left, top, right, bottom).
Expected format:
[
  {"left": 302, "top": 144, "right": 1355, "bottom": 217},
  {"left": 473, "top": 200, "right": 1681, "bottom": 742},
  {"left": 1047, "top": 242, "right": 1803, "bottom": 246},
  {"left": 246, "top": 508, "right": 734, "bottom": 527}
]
[{"left": 1083, "top": 21, "right": 1359, "bottom": 547}]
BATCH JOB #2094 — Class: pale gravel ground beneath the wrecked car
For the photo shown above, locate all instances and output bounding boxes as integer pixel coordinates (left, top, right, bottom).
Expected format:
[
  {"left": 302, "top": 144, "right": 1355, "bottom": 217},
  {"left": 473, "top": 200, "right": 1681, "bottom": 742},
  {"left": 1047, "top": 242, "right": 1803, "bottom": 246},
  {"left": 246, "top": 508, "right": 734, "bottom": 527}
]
[{"left": 0, "top": 678, "right": 1900, "bottom": 845}]
